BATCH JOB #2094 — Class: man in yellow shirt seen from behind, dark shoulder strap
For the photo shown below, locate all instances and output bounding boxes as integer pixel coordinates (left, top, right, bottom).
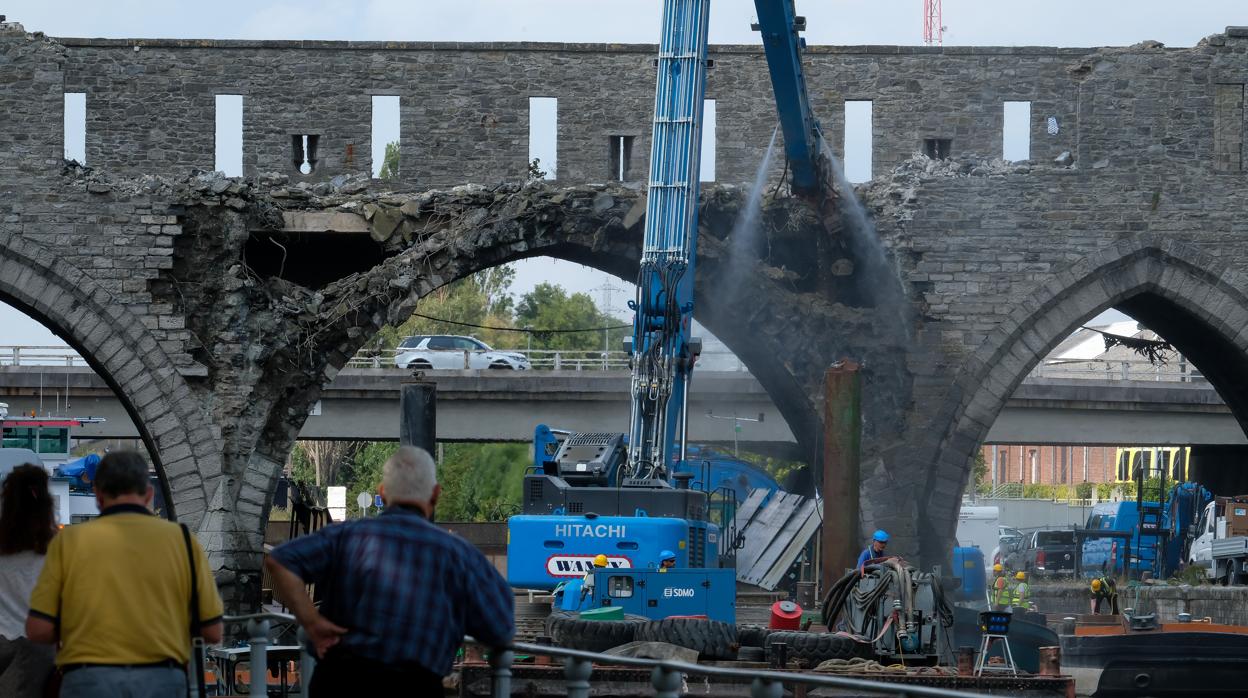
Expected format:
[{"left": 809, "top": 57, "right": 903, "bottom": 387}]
[{"left": 26, "top": 451, "right": 222, "bottom": 698}]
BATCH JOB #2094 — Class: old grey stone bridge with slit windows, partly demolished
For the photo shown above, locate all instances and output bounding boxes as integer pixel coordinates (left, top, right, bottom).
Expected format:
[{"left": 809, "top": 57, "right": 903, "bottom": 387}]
[{"left": 0, "top": 24, "right": 1248, "bottom": 611}]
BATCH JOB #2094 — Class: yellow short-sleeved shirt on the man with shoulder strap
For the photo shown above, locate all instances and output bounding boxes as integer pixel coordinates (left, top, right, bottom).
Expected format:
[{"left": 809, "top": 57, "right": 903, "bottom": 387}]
[{"left": 30, "top": 504, "right": 222, "bottom": 666}]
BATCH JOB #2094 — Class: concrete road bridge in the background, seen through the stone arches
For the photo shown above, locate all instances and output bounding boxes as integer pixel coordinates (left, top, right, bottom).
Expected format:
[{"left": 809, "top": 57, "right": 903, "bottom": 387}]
[{"left": 7, "top": 366, "right": 1248, "bottom": 447}]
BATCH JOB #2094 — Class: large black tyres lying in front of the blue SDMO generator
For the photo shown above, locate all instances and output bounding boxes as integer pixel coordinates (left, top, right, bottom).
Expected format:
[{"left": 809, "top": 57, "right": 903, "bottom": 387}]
[{"left": 545, "top": 611, "right": 738, "bottom": 659}]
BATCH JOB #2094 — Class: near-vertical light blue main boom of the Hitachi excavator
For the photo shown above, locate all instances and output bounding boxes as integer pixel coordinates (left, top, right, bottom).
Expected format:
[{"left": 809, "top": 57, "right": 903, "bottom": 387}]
[{"left": 626, "top": 0, "right": 710, "bottom": 477}]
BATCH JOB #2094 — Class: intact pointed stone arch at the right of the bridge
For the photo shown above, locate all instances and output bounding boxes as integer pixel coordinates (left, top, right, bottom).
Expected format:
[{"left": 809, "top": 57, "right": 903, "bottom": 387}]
[{"left": 919, "top": 236, "right": 1248, "bottom": 559}]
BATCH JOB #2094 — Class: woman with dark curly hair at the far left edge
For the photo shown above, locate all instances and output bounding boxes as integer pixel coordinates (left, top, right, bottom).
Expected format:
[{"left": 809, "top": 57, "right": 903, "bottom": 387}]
[{"left": 0, "top": 465, "right": 56, "bottom": 698}]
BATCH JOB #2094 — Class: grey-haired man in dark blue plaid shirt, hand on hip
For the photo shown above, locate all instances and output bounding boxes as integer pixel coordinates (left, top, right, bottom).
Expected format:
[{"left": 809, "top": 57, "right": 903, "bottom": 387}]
[{"left": 265, "top": 446, "right": 515, "bottom": 698}]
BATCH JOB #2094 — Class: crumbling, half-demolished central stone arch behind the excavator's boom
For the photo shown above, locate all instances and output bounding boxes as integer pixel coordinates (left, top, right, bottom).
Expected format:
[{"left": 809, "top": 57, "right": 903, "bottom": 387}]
[{"left": 235, "top": 187, "right": 819, "bottom": 518}]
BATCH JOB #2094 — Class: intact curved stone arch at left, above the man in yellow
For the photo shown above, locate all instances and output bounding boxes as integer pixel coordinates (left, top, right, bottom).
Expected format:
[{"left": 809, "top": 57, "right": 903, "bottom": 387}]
[{"left": 0, "top": 235, "right": 221, "bottom": 531}]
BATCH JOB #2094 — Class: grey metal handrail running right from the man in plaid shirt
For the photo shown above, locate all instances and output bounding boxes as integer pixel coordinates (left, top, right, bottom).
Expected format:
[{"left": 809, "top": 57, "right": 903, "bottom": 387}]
[{"left": 464, "top": 638, "right": 980, "bottom": 698}]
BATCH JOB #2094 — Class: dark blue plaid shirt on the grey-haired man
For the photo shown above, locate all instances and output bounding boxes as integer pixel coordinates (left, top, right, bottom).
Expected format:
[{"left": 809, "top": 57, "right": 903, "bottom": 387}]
[{"left": 271, "top": 507, "right": 515, "bottom": 676}]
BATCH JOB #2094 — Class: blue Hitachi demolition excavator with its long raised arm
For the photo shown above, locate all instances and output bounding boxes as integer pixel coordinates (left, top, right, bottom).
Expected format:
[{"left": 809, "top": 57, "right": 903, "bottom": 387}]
[{"left": 508, "top": 0, "right": 831, "bottom": 622}]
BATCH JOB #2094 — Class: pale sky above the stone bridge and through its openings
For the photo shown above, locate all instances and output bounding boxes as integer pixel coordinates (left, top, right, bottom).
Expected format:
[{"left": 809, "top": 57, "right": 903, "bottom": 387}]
[{"left": 0, "top": 0, "right": 1248, "bottom": 345}]
